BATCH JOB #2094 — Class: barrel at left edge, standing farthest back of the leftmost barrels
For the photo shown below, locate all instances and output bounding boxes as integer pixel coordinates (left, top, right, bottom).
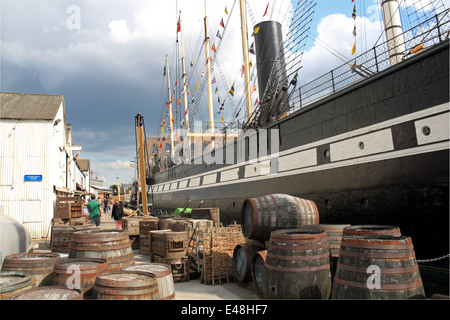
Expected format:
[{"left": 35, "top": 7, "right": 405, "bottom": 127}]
[{"left": 2, "top": 253, "right": 61, "bottom": 288}]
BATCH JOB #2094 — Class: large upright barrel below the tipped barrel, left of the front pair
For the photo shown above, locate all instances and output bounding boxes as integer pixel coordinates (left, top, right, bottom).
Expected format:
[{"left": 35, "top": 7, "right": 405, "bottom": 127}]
[{"left": 262, "top": 229, "right": 331, "bottom": 299}]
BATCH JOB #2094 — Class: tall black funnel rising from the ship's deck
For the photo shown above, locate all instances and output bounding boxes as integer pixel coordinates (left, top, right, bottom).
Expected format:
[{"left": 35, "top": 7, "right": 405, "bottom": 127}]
[{"left": 253, "top": 21, "right": 287, "bottom": 107}]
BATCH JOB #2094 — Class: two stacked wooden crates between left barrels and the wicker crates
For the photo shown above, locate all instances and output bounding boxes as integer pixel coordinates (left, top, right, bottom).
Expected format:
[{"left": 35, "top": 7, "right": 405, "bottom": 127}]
[{"left": 150, "top": 229, "right": 189, "bottom": 282}]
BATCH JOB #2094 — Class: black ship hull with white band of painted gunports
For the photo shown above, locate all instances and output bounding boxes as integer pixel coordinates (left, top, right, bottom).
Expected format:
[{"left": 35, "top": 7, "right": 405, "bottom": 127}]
[{"left": 149, "top": 41, "right": 449, "bottom": 263}]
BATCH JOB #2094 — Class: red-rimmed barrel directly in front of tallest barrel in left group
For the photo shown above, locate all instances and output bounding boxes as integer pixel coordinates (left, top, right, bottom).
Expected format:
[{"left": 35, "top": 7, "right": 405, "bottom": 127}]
[{"left": 53, "top": 258, "right": 109, "bottom": 294}]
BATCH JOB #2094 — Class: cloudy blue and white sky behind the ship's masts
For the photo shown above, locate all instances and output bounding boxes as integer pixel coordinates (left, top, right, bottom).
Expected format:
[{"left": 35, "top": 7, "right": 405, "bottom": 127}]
[{"left": 0, "top": 0, "right": 434, "bottom": 186}]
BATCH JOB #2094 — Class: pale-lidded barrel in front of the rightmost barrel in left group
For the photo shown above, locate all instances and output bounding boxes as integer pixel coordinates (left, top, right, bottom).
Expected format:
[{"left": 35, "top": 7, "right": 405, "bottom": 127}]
[{"left": 92, "top": 271, "right": 159, "bottom": 300}]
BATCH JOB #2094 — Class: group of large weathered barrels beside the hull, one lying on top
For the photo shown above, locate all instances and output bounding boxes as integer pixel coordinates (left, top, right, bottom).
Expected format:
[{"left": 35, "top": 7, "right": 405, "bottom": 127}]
[{"left": 233, "top": 194, "right": 425, "bottom": 299}]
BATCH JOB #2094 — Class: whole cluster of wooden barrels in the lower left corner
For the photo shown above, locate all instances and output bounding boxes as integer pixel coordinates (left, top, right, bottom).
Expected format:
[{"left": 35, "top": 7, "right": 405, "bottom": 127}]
[{"left": 0, "top": 229, "right": 175, "bottom": 300}]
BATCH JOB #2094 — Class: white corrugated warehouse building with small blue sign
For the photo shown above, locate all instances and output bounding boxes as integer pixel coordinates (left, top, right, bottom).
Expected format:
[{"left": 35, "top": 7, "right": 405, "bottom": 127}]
[{"left": 0, "top": 92, "right": 89, "bottom": 238}]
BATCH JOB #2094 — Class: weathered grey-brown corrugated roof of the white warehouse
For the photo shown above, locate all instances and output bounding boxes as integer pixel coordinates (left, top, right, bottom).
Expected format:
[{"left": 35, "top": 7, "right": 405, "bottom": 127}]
[{"left": 0, "top": 92, "right": 64, "bottom": 120}]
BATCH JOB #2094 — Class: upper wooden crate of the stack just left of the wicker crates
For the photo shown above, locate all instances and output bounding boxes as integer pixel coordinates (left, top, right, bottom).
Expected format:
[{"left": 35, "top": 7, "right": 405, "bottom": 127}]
[{"left": 150, "top": 230, "right": 188, "bottom": 259}]
